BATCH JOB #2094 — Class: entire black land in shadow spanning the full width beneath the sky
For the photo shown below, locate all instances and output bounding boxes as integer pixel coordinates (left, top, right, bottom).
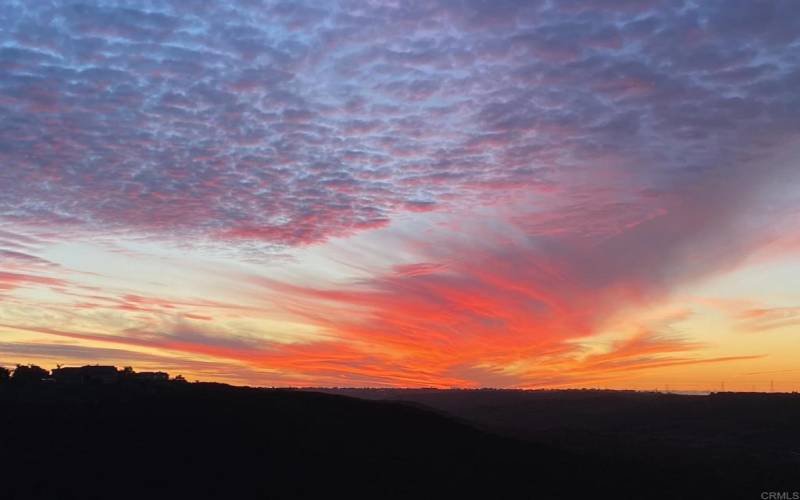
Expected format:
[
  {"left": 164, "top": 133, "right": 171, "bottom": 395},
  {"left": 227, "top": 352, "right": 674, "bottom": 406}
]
[{"left": 0, "top": 381, "right": 800, "bottom": 499}]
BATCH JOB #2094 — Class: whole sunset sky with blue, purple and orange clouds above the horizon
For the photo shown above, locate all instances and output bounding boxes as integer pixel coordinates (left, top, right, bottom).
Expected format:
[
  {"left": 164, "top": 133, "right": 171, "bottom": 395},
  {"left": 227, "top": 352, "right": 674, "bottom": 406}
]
[{"left": 0, "top": 0, "right": 800, "bottom": 391}]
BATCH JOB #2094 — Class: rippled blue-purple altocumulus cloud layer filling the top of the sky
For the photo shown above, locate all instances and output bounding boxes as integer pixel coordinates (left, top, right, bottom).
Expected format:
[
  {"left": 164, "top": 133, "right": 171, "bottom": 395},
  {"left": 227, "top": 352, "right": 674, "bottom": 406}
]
[{"left": 0, "top": 1, "right": 800, "bottom": 245}]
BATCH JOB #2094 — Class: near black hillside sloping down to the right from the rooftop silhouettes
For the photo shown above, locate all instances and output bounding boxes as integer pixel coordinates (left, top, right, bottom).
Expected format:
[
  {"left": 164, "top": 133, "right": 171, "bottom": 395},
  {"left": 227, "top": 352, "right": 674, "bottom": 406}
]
[{"left": 0, "top": 366, "right": 590, "bottom": 499}]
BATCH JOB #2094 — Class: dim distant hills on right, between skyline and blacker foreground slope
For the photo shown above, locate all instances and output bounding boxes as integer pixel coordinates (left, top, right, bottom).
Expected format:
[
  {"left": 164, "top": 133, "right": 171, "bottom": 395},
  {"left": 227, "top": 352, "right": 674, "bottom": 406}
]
[{"left": 329, "top": 389, "right": 800, "bottom": 456}]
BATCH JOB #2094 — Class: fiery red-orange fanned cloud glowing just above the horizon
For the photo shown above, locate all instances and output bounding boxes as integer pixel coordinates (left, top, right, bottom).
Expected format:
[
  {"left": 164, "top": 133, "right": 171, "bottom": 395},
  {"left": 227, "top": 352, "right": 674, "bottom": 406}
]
[{"left": 241, "top": 163, "right": 784, "bottom": 386}]
